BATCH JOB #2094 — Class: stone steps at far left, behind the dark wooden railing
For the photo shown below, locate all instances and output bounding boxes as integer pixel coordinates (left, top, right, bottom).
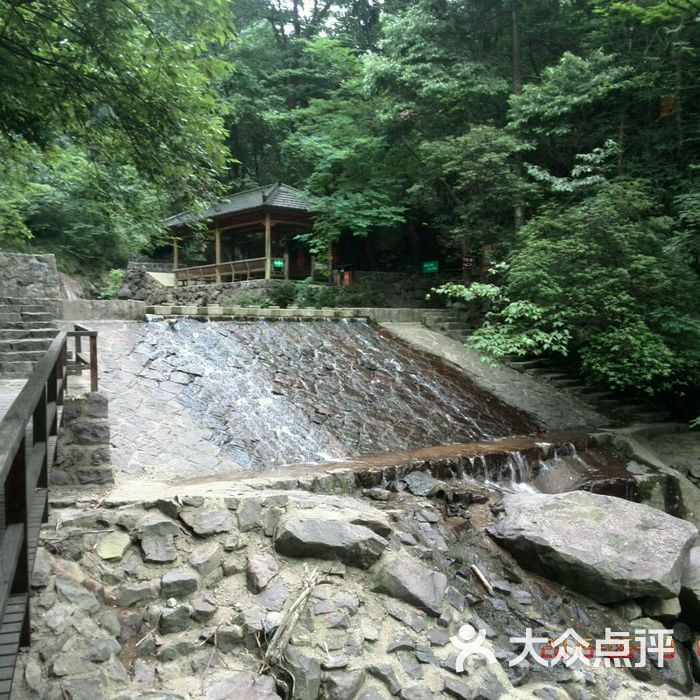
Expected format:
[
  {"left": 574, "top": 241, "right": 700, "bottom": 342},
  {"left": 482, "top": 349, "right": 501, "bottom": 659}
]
[{"left": 0, "top": 297, "right": 58, "bottom": 378}]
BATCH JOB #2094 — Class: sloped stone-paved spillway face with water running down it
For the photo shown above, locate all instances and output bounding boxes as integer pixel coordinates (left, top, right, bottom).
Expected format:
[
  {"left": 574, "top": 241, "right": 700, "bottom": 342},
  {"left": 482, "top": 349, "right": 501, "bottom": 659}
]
[{"left": 100, "top": 319, "right": 535, "bottom": 478}]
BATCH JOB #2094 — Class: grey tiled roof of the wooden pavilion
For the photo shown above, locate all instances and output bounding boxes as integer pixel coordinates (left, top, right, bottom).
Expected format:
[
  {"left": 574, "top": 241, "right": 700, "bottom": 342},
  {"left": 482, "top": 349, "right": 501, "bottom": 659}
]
[{"left": 163, "top": 182, "right": 310, "bottom": 228}]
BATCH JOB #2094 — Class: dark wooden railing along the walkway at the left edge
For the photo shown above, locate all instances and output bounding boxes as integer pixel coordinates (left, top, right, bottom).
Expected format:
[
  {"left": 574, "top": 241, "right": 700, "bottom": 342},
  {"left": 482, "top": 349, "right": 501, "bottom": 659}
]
[{"left": 0, "top": 326, "right": 97, "bottom": 698}]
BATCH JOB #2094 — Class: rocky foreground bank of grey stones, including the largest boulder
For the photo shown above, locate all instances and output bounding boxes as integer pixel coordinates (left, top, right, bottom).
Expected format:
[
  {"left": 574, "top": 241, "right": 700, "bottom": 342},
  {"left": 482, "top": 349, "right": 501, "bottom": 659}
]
[{"left": 14, "top": 472, "right": 700, "bottom": 700}]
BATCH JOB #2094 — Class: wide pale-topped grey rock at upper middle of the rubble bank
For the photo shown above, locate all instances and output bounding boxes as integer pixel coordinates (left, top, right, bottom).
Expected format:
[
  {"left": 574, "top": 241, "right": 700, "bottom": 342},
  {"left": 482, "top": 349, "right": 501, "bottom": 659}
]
[{"left": 275, "top": 508, "right": 389, "bottom": 569}]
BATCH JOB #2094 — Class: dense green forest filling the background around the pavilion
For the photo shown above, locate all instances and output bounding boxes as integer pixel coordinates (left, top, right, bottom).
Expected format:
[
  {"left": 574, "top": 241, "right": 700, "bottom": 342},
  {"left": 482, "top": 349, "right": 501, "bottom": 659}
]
[{"left": 0, "top": 0, "right": 700, "bottom": 402}]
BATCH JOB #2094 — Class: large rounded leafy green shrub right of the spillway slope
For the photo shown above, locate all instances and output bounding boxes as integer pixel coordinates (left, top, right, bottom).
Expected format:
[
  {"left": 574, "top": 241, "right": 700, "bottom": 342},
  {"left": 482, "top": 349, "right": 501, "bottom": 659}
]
[{"left": 446, "top": 181, "right": 700, "bottom": 393}]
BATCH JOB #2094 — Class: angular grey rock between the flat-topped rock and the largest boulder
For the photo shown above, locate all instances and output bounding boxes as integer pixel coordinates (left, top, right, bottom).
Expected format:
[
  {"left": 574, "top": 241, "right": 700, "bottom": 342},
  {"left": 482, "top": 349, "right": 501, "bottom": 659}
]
[{"left": 374, "top": 555, "right": 447, "bottom": 615}]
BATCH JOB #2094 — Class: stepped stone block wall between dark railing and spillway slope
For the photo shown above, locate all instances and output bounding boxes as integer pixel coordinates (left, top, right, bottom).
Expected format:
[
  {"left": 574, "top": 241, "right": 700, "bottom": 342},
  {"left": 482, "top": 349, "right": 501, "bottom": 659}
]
[{"left": 51, "top": 392, "right": 114, "bottom": 484}]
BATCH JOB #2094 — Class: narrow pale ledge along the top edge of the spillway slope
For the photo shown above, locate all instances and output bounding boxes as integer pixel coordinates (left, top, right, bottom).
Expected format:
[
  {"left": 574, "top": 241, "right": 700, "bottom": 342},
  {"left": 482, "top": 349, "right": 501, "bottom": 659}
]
[{"left": 145, "top": 306, "right": 440, "bottom": 323}]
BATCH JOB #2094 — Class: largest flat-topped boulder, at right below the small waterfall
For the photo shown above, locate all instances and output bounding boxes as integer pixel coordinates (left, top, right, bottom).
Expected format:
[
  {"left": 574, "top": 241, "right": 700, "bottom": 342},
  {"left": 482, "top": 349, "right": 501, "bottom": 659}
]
[{"left": 489, "top": 491, "right": 698, "bottom": 603}]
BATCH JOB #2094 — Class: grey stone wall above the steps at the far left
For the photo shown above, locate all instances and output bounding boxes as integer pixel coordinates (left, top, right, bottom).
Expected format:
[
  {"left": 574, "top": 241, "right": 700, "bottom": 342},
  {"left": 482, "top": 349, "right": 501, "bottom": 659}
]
[{"left": 0, "top": 251, "right": 59, "bottom": 299}]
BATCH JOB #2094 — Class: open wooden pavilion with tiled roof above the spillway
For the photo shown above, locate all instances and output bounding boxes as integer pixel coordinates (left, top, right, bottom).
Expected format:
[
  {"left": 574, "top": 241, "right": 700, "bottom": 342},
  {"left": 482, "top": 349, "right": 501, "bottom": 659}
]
[{"left": 163, "top": 182, "right": 313, "bottom": 286}]
